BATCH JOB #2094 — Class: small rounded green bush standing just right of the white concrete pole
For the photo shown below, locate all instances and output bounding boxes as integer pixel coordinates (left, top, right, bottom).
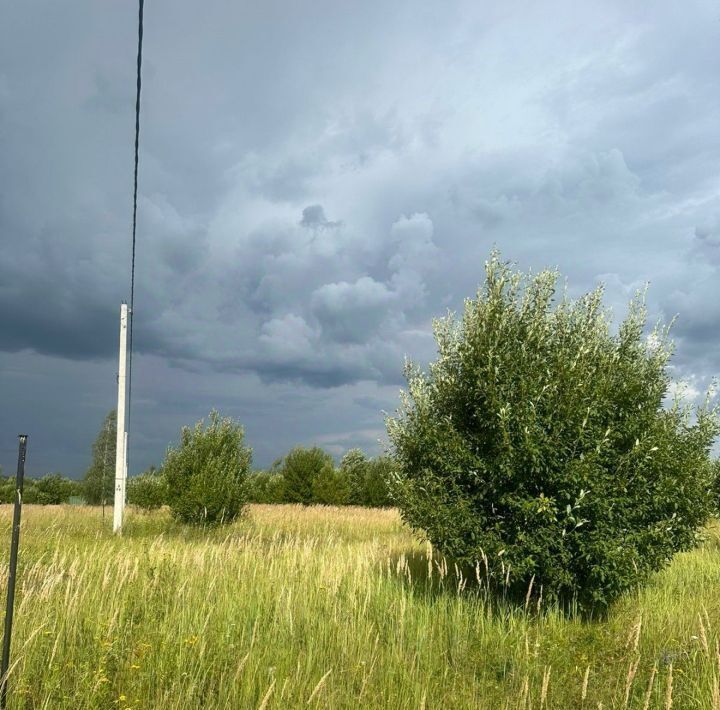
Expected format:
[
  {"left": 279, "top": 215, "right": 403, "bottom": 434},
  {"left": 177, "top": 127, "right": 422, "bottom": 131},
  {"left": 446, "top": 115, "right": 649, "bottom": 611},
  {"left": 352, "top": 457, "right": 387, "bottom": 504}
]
[{"left": 162, "top": 411, "right": 252, "bottom": 525}]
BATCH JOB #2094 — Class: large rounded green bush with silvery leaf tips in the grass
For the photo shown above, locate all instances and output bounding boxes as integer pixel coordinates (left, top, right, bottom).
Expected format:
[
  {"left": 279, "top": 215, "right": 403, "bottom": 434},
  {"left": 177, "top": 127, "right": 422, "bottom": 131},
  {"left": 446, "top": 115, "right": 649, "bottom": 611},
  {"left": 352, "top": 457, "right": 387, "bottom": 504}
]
[{"left": 387, "top": 254, "right": 718, "bottom": 607}]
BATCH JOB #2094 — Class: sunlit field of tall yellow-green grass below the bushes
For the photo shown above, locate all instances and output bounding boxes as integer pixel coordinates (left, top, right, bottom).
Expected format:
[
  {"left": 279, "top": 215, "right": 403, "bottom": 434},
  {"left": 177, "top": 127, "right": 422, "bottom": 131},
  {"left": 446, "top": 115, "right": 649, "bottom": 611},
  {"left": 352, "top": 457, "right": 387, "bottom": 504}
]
[{"left": 0, "top": 505, "right": 720, "bottom": 710}]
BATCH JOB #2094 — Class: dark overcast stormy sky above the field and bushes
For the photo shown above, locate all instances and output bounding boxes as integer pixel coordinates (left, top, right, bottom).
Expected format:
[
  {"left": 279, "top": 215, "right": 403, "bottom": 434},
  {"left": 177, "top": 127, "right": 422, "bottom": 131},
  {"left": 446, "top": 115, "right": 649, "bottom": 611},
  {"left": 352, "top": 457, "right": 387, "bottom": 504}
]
[{"left": 0, "top": 0, "right": 720, "bottom": 476}]
